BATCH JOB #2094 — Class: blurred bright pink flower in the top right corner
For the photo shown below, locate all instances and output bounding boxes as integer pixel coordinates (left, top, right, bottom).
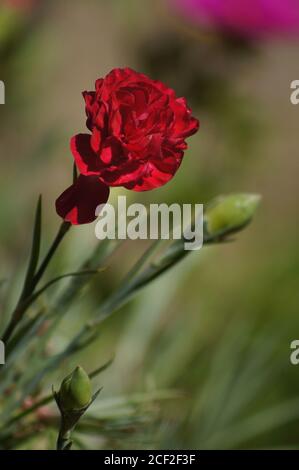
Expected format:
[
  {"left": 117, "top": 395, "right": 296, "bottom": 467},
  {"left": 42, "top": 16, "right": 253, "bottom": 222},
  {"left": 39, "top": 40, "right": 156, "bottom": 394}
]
[{"left": 170, "top": 0, "right": 299, "bottom": 38}]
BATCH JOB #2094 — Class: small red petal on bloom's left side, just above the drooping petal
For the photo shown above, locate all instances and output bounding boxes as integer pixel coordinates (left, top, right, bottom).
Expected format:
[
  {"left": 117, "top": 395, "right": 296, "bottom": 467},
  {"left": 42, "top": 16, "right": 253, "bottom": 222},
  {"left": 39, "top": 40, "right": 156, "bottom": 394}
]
[{"left": 71, "top": 134, "right": 100, "bottom": 176}]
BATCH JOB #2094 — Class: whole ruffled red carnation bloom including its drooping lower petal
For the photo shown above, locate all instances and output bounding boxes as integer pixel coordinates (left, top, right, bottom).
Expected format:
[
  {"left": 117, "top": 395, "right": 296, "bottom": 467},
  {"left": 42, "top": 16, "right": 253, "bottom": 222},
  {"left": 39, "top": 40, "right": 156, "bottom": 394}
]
[{"left": 57, "top": 68, "right": 199, "bottom": 223}]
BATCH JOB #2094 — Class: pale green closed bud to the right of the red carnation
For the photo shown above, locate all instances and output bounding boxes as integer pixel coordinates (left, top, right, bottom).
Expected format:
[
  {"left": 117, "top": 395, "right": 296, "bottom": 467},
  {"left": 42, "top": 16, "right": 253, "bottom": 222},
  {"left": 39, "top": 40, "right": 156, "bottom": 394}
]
[{"left": 204, "top": 193, "right": 261, "bottom": 235}]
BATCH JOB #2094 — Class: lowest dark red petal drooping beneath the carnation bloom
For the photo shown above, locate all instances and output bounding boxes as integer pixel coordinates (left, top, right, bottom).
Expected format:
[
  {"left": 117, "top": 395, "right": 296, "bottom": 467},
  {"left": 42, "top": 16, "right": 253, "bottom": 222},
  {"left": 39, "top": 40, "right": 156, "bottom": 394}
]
[{"left": 56, "top": 175, "right": 109, "bottom": 225}]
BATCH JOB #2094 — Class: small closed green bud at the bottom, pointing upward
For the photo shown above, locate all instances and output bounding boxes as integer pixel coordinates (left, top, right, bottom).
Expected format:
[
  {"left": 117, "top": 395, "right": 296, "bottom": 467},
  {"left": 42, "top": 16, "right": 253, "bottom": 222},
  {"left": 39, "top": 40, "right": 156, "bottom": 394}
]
[{"left": 59, "top": 366, "right": 92, "bottom": 411}]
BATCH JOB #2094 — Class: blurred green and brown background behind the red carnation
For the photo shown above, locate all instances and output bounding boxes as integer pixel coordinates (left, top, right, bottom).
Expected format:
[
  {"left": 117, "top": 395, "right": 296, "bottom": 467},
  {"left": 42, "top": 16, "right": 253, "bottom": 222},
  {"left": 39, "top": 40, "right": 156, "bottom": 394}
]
[{"left": 0, "top": 0, "right": 299, "bottom": 449}]
